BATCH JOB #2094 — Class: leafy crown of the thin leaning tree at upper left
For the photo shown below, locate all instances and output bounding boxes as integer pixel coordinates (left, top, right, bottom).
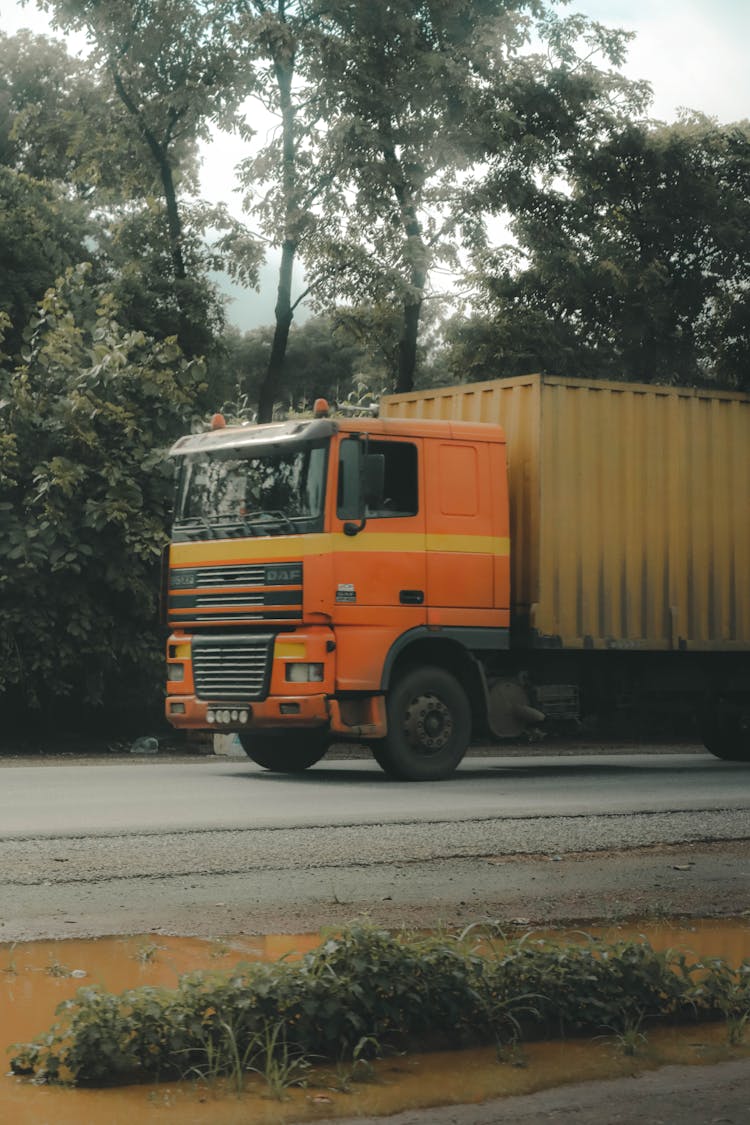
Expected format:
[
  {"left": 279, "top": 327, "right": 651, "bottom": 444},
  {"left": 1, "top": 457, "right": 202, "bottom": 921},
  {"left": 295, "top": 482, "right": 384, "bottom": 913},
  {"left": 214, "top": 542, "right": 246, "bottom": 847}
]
[{"left": 0, "top": 27, "right": 259, "bottom": 364}]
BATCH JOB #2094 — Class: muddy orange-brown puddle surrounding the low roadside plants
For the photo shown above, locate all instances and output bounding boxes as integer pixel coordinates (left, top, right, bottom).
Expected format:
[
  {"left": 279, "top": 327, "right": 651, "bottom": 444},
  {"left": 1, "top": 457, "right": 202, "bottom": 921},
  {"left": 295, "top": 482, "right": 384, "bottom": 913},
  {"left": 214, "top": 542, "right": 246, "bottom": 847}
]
[{"left": 0, "top": 918, "right": 750, "bottom": 1125}]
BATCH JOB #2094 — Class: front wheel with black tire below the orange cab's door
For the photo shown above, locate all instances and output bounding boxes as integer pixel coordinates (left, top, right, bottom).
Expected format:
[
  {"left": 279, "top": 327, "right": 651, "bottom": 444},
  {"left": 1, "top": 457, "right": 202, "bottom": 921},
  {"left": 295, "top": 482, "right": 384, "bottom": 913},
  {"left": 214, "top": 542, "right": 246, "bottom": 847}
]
[{"left": 372, "top": 666, "right": 471, "bottom": 781}]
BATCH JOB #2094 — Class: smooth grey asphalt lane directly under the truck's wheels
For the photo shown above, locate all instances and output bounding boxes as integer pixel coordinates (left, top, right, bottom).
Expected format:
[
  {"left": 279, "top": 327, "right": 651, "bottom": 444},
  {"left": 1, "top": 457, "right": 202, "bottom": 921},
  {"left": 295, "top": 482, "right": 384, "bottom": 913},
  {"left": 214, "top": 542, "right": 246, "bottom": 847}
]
[{"left": 0, "top": 753, "right": 750, "bottom": 838}]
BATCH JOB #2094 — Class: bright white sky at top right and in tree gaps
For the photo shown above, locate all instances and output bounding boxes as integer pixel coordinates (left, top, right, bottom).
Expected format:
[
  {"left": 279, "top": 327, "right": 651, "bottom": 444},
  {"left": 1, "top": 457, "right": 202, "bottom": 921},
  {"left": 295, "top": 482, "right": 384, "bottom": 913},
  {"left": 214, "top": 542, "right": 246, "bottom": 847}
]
[{"left": 0, "top": 0, "right": 750, "bottom": 329}]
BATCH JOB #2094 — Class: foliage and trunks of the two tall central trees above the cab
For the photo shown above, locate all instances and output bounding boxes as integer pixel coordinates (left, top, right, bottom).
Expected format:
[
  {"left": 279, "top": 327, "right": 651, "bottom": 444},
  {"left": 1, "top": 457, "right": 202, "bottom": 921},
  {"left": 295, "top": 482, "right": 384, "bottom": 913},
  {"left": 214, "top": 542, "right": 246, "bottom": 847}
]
[{"left": 232, "top": 0, "right": 647, "bottom": 409}]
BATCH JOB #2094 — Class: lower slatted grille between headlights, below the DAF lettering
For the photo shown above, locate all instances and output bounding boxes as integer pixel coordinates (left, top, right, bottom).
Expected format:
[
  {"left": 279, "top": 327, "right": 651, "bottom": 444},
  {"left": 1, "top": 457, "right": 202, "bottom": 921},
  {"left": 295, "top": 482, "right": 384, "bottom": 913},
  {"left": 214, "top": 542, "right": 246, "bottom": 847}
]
[{"left": 192, "top": 636, "right": 273, "bottom": 701}]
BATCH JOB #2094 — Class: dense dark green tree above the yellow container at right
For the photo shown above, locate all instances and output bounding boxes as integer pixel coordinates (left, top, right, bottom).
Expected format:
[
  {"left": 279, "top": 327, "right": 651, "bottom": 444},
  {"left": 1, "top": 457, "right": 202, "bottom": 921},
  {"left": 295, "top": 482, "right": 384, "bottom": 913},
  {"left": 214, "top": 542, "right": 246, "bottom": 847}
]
[{"left": 454, "top": 115, "right": 750, "bottom": 386}]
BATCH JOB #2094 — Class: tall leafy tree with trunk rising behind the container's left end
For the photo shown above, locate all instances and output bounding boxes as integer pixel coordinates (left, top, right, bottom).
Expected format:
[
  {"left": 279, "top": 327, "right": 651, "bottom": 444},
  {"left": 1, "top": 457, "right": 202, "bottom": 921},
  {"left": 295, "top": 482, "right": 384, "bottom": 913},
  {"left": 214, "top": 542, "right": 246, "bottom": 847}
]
[{"left": 306, "top": 0, "right": 647, "bottom": 390}]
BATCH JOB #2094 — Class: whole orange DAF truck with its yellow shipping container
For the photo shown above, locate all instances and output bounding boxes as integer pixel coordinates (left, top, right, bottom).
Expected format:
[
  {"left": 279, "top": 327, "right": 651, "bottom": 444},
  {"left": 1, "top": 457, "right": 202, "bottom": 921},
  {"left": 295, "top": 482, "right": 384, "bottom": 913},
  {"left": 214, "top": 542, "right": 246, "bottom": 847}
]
[{"left": 164, "top": 376, "right": 750, "bottom": 781}]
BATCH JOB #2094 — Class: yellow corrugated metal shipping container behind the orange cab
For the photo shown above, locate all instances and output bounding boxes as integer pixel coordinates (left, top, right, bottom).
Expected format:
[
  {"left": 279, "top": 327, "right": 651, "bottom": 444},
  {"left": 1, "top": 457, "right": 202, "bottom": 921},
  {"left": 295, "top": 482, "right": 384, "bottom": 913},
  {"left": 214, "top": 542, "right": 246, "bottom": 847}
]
[{"left": 380, "top": 375, "right": 750, "bottom": 651}]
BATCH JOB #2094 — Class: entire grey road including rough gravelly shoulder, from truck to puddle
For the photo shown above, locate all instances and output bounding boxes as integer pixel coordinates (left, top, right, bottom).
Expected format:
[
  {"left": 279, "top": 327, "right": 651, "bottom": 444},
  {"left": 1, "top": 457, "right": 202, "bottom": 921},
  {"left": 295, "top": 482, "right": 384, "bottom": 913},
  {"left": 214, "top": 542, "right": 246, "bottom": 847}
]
[{"left": 0, "top": 753, "right": 750, "bottom": 941}]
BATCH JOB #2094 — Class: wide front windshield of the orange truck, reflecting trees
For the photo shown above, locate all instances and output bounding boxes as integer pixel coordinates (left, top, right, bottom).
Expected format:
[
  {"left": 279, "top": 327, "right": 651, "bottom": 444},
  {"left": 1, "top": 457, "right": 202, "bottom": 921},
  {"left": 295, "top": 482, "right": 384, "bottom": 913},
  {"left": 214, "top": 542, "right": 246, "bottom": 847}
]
[{"left": 173, "top": 442, "right": 327, "bottom": 541}]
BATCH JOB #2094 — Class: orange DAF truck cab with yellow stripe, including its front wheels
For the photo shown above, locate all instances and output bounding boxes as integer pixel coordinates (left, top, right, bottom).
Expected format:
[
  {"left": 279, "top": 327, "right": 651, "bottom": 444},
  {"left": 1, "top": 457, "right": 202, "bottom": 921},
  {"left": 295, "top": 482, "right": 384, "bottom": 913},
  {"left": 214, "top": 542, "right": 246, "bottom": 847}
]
[{"left": 165, "top": 403, "right": 510, "bottom": 780}]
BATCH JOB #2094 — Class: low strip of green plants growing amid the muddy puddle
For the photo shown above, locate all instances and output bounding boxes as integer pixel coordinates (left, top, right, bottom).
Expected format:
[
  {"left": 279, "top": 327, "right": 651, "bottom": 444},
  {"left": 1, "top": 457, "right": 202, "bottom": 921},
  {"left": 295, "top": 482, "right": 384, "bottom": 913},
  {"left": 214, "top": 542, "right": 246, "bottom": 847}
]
[{"left": 11, "top": 925, "right": 750, "bottom": 1092}]
